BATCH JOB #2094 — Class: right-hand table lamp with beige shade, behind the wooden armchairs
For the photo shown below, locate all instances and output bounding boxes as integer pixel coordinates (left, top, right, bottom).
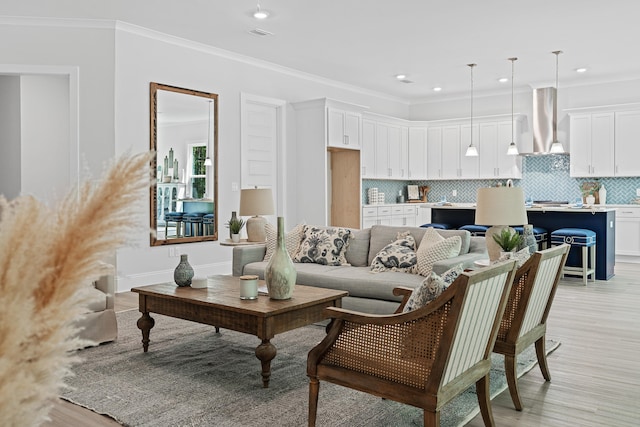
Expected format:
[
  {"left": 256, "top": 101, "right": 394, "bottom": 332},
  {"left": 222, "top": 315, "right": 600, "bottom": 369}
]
[{"left": 475, "top": 187, "right": 528, "bottom": 261}]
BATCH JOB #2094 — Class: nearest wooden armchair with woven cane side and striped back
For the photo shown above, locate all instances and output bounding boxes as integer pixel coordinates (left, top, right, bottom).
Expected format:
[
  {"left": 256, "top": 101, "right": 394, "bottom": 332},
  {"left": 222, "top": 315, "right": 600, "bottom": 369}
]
[{"left": 307, "top": 260, "right": 516, "bottom": 426}]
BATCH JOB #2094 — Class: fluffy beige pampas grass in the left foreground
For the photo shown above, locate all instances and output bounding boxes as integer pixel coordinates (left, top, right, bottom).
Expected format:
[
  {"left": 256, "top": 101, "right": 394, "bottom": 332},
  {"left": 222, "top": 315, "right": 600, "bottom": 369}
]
[{"left": 0, "top": 153, "right": 152, "bottom": 426}]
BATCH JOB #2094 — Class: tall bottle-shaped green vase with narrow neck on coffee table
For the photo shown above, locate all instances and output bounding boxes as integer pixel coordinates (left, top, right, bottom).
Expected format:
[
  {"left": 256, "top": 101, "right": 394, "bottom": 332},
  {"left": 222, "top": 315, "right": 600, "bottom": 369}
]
[{"left": 264, "top": 216, "right": 297, "bottom": 299}]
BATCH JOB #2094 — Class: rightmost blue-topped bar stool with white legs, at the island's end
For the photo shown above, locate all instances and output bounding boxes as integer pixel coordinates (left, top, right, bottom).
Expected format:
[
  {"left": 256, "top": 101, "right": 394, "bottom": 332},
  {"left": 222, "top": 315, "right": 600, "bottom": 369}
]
[{"left": 551, "top": 228, "right": 596, "bottom": 286}]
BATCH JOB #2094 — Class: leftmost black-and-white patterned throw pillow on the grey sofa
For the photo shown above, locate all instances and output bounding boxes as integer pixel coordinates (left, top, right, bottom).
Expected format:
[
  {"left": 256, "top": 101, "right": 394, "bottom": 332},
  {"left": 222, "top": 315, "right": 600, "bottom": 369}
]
[{"left": 293, "top": 225, "right": 351, "bottom": 265}]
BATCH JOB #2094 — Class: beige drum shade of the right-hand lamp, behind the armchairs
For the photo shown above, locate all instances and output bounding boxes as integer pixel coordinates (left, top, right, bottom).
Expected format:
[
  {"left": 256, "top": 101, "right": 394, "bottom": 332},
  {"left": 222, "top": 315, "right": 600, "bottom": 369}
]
[{"left": 476, "top": 187, "right": 528, "bottom": 225}]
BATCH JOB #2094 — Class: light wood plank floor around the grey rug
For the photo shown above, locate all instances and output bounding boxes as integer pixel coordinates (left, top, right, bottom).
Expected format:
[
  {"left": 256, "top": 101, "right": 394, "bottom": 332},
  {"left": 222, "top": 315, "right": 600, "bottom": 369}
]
[{"left": 45, "top": 264, "right": 640, "bottom": 427}]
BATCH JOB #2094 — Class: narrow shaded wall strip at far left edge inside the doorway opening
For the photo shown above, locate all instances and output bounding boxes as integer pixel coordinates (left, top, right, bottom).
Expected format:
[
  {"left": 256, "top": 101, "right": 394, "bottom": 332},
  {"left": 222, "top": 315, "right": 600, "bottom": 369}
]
[{"left": 0, "top": 76, "right": 22, "bottom": 199}]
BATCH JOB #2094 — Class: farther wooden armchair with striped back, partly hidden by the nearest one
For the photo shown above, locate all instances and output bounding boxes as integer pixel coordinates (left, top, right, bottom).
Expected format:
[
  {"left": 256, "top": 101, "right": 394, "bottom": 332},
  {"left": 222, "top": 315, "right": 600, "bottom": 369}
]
[{"left": 493, "top": 244, "right": 571, "bottom": 411}]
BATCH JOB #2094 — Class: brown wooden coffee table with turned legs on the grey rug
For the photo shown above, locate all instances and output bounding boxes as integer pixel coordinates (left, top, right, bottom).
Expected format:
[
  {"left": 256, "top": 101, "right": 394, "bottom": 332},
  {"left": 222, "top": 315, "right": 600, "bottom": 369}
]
[{"left": 131, "top": 276, "right": 348, "bottom": 387}]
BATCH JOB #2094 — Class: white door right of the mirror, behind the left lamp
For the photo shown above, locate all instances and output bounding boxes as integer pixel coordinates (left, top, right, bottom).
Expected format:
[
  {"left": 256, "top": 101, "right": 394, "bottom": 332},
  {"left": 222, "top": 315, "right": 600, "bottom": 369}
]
[{"left": 240, "top": 94, "right": 286, "bottom": 216}]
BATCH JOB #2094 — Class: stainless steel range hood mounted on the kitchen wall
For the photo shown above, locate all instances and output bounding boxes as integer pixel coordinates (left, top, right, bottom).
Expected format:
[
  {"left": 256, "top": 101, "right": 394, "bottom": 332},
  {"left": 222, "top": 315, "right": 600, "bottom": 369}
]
[{"left": 520, "top": 87, "right": 569, "bottom": 156}]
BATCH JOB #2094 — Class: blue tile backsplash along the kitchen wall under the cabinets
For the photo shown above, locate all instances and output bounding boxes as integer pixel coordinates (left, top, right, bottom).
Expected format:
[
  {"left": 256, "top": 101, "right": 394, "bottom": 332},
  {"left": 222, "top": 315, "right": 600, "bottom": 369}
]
[{"left": 362, "top": 155, "right": 640, "bottom": 204}]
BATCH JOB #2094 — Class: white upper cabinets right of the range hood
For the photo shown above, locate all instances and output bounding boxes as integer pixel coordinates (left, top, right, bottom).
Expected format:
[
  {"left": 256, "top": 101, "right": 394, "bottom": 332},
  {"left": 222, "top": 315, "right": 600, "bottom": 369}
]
[{"left": 569, "top": 107, "right": 640, "bottom": 177}]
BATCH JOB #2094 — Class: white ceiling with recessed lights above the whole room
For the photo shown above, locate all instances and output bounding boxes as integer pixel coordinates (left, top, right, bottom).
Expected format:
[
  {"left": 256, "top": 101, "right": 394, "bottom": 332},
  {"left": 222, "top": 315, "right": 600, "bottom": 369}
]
[{"left": 0, "top": 0, "right": 640, "bottom": 102}]
